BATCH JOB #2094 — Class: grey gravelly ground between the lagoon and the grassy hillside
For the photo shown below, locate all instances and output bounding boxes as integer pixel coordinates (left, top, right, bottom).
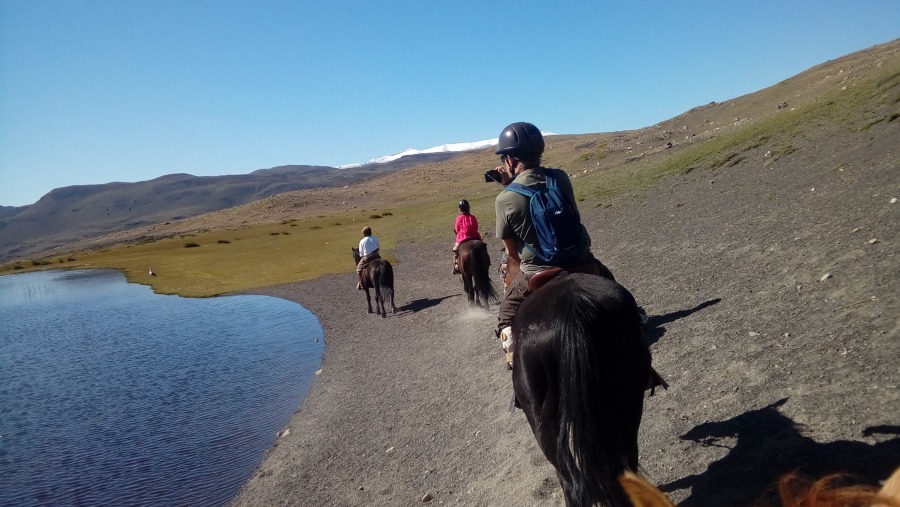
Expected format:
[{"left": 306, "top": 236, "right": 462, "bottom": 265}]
[{"left": 233, "top": 122, "right": 900, "bottom": 506}]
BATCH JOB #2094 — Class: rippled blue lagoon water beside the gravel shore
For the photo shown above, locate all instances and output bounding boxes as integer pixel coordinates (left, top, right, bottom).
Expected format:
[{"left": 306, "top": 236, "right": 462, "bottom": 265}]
[{"left": 0, "top": 270, "right": 324, "bottom": 506}]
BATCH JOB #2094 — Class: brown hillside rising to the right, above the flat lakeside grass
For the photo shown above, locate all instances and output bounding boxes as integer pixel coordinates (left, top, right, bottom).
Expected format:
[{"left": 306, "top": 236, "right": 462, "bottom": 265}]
[{"left": 44, "top": 40, "right": 900, "bottom": 266}]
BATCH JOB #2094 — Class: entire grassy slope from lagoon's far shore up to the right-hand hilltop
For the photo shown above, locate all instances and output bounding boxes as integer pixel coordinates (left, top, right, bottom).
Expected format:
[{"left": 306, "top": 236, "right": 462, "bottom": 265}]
[{"left": 0, "top": 41, "right": 900, "bottom": 296}]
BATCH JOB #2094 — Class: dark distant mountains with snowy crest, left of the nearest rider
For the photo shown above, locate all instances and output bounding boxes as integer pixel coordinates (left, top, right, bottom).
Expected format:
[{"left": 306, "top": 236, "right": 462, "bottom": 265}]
[{"left": 0, "top": 151, "right": 460, "bottom": 260}]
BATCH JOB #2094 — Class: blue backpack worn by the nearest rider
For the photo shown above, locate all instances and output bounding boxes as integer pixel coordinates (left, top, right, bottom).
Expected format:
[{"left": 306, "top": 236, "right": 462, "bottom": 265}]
[{"left": 506, "top": 169, "right": 585, "bottom": 266}]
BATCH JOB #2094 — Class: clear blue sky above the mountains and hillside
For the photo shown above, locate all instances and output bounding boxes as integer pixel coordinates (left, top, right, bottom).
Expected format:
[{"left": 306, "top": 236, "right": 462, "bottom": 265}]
[{"left": 0, "top": 0, "right": 900, "bottom": 206}]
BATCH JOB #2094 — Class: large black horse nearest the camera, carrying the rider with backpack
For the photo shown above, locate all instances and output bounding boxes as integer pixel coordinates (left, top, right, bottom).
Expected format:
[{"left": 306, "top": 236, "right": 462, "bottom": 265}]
[{"left": 512, "top": 273, "right": 662, "bottom": 507}]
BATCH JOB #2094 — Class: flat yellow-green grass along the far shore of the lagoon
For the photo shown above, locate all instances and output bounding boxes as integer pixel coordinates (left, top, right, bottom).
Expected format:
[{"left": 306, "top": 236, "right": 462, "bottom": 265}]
[{"left": 0, "top": 198, "right": 472, "bottom": 297}]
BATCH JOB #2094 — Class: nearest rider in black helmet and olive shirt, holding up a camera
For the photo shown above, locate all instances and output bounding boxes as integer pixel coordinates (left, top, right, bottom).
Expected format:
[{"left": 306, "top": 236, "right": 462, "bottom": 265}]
[{"left": 494, "top": 122, "right": 593, "bottom": 361}]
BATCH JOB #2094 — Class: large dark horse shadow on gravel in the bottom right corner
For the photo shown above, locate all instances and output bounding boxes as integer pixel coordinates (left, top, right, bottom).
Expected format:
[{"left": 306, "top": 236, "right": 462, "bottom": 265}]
[{"left": 659, "top": 398, "right": 900, "bottom": 507}]
